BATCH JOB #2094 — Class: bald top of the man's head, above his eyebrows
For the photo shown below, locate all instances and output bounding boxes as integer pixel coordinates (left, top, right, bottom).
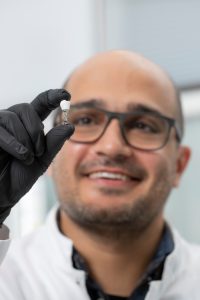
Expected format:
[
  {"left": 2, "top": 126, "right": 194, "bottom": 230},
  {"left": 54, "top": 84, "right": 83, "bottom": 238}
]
[{"left": 64, "top": 51, "right": 183, "bottom": 139}]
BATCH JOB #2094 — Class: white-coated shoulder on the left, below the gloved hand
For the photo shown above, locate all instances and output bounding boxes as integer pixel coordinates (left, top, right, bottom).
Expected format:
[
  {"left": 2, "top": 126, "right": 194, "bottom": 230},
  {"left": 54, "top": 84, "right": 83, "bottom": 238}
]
[{"left": 0, "top": 224, "right": 88, "bottom": 300}]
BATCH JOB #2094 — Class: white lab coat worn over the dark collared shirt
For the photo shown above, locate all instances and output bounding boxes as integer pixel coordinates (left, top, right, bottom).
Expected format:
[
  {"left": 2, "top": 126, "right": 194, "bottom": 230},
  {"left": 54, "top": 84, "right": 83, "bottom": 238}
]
[{"left": 0, "top": 206, "right": 200, "bottom": 300}]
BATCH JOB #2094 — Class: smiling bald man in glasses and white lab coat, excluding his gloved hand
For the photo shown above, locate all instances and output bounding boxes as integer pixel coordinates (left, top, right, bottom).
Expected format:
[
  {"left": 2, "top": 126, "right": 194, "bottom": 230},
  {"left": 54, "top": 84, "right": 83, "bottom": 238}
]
[{"left": 0, "top": 51, "right": 200, "bottom": 300}]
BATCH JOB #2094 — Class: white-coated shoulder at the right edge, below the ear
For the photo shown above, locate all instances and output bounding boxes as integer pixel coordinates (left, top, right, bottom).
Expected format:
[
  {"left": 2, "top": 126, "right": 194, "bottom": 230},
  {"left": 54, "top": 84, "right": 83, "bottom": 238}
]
[{"left": 154, "top": 229, "right": 200, "bottom": 300}]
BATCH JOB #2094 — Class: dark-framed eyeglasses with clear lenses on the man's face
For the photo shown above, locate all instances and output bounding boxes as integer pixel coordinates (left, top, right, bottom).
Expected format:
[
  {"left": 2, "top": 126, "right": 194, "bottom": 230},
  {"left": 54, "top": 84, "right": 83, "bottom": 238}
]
[{"left": 54, "top": 103, "right": 181, "bottom": 151}]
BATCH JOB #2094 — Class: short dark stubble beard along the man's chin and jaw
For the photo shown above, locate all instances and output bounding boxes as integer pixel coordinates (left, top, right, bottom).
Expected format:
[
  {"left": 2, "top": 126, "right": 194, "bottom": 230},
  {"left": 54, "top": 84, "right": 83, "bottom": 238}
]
[{"left": 61, "top": 172, "right": 171, "bottom": 239}]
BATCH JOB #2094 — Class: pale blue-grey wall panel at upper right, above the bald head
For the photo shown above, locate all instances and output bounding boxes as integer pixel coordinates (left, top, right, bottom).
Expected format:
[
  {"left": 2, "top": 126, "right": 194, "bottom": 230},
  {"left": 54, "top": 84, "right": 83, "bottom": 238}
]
[{"left": 104, "top": 0, "right": 200, "bottom": 86}]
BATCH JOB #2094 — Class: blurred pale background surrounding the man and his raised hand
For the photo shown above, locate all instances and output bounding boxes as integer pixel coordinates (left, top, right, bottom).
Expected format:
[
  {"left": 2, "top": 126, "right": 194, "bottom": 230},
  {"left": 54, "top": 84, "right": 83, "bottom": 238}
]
[{"left": 0, "top": 0, "right": 200, "bottom": 243}]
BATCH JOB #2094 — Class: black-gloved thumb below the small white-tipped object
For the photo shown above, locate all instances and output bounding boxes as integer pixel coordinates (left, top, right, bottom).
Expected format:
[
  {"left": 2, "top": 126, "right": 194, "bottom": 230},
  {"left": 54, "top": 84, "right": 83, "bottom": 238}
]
[{"left": 41, "top": 124, "right": 75, "bottom": 168}]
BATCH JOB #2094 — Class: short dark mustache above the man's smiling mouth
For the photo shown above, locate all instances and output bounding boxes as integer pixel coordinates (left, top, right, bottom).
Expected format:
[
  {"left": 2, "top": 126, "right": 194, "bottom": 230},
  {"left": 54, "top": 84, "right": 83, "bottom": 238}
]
[{"left": 79, "top": 157, "right": 147, "bottom": 179}]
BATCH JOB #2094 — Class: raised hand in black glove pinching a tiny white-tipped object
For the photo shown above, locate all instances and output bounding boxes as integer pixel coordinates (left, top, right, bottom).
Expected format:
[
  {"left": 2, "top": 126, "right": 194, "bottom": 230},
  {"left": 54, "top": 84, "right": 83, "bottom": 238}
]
[{"left": 0, "top": 89, "right": 74, "bottom": 224}]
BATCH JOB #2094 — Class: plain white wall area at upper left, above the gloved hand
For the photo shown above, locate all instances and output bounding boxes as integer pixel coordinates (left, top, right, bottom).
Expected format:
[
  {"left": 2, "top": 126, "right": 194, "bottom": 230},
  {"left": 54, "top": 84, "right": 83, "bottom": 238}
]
[{"left": 0, "top": 0, "right": 97, "bottom": 109}]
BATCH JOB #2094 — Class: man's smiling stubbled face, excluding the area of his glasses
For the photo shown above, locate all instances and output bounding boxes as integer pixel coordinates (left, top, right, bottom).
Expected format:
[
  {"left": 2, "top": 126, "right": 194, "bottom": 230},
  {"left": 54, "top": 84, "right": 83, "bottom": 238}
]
[{"left": 53, "top": 52, "right": 189, "bottom": 231}]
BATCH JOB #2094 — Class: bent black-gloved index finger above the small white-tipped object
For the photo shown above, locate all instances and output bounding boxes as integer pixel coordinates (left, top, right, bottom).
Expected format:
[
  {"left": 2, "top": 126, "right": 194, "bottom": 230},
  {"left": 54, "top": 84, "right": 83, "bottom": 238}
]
[{"left": 31, "top": 89, "right": 71, "bottom": 121}]
